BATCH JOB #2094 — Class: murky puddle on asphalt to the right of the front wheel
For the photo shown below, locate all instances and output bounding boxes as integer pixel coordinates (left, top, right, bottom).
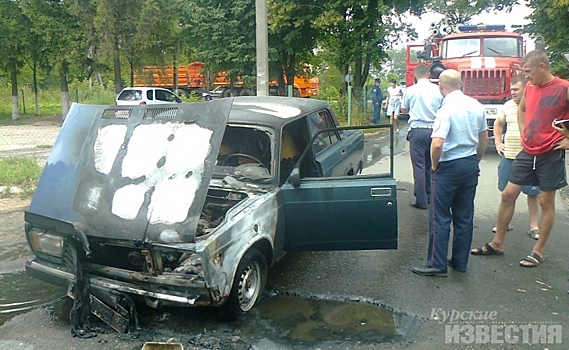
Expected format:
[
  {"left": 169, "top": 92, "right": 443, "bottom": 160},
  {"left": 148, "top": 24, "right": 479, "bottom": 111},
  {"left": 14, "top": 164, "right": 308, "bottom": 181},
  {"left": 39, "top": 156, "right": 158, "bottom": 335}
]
[{"left": 243, "top": 296, "right": 419, "bottom": 345}]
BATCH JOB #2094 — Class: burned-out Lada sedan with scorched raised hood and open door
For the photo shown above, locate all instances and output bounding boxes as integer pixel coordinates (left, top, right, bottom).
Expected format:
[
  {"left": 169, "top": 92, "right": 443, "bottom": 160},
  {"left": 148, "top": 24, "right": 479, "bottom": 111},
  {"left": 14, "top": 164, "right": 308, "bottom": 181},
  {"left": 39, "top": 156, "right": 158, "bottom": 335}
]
[{"left": 25, "top": 97, "right": 397, "bottom": 328}]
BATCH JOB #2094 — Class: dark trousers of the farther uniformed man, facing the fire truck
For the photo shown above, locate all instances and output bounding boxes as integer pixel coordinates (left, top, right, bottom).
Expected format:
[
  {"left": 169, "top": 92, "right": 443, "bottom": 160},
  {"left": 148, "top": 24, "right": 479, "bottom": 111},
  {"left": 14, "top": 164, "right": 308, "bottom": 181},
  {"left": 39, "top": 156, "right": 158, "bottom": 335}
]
[{"left": 407, "top": 128, "right": 433, "bottom": 207}]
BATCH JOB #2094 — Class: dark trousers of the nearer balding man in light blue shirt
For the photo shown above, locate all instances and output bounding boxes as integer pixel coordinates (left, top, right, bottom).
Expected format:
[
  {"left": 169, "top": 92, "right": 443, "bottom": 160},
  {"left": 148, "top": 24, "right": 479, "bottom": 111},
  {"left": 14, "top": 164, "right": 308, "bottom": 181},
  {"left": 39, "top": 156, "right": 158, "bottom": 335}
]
[{"left": 427, "top": 156, "right": 480, "bottom": 271}]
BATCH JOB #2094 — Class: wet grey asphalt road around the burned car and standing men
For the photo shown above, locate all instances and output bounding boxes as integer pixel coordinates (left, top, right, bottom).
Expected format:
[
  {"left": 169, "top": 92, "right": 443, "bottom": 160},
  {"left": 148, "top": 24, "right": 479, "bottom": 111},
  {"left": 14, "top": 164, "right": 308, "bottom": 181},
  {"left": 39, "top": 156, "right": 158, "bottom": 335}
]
[{"left": 0, "top": 121, "right": 569, "bottom": 350}]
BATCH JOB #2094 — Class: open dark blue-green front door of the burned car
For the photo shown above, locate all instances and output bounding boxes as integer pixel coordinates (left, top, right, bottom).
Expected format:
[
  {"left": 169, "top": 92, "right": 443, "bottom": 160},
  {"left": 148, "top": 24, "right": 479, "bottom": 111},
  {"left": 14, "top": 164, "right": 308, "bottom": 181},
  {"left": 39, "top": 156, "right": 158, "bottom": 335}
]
[{"left": 281, "top": 126, "right": 398, "bottom": 251}]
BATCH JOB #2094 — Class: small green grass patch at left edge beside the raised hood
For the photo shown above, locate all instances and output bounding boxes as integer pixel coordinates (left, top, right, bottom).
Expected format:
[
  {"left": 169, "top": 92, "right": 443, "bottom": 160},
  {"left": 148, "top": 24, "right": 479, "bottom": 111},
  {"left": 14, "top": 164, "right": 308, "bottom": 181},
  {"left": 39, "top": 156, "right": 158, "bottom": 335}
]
[{"left": 0, "top": 158, "right": 42, "bottom": 198}]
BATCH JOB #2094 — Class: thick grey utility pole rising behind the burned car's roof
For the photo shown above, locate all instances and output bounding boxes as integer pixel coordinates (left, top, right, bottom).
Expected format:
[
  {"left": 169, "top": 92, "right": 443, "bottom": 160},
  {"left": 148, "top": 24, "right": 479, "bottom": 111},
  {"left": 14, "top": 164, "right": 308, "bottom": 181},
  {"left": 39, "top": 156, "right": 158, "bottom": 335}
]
[{"left": 255, "top": 0, "right": 269, "bottom": 96}]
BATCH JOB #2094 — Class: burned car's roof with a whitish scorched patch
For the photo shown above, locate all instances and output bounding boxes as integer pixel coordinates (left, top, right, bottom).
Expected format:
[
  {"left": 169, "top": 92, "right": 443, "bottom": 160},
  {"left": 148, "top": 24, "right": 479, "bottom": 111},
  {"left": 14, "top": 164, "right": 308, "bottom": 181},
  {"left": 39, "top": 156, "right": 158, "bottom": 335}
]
[{"left": 229, "top": 96, "right": 328, "bottom": 129}]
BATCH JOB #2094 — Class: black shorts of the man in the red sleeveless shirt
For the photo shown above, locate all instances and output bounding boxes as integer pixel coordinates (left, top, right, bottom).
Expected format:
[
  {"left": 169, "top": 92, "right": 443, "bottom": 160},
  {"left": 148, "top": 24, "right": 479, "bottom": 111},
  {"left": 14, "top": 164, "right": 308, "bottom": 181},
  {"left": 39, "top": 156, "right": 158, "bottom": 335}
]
[{"left": 510, "top": 150, "right": 567, "bottom": 191}]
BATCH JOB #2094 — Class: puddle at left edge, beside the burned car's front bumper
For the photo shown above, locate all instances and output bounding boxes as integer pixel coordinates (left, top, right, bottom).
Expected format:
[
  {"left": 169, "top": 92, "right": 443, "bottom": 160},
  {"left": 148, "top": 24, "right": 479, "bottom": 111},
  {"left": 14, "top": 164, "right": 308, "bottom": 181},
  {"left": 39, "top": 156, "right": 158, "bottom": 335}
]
[{"left": 0, "top": 273, "right": 65, "bottom": 326}]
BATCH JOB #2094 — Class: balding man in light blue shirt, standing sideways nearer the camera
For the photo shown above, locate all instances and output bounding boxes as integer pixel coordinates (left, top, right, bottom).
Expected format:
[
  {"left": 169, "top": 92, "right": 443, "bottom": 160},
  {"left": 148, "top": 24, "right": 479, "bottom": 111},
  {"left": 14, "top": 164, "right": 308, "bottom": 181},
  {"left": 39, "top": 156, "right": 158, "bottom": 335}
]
[{"left": 413, "top": 69, "right": 488, "bottom": 277}]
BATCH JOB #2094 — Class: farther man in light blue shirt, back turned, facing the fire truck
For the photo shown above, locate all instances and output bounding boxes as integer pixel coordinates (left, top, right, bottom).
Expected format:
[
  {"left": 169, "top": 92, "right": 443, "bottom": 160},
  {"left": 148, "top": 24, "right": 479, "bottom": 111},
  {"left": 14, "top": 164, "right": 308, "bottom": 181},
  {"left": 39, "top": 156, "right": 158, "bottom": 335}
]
[{"left": 401, "top": 64, "right": 443, "bottom": 209}]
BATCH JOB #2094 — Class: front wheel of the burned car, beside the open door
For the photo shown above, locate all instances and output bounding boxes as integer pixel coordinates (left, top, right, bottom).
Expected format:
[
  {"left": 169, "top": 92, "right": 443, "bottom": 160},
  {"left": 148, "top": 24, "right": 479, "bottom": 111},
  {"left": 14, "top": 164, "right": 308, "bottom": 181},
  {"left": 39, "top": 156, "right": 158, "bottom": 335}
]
[{"left": 219, "top": 249, "right": 268, "bottom": 321}]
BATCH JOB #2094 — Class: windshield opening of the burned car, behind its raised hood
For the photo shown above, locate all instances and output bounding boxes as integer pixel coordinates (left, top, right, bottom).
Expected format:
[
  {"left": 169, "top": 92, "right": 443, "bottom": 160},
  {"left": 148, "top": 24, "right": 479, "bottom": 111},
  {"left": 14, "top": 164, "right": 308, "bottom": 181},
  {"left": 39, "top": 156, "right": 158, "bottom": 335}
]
[{"left": 214, "top": 126, "right": 274, "bottom": 183}]
